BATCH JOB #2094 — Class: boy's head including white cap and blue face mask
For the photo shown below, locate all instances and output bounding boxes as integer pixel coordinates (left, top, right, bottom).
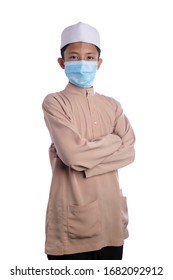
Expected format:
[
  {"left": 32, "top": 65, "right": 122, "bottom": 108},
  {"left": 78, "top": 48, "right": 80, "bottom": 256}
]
[{"left": 58, "top": 22, "right": 102, "bottom": 88}]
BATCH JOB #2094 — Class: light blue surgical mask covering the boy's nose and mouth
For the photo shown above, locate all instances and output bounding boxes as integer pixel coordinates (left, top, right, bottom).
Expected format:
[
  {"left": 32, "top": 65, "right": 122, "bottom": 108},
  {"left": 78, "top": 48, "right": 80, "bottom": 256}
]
[{"left": 64, "top": 60, "right": 98, "bottom": 88}]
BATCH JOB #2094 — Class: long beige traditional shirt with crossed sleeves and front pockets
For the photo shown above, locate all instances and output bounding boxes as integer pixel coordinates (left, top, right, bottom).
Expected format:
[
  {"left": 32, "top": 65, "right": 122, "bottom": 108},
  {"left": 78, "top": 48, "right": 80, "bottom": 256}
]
[{"left": 43, "top": 83, "right": 135, "bottom": 255}]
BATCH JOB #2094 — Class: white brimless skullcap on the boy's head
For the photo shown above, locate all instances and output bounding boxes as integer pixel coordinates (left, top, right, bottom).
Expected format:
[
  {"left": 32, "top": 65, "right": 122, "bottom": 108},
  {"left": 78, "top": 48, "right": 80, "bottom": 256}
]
[{"left": 60, "top": 22, "right": 100, "bottom": 49}]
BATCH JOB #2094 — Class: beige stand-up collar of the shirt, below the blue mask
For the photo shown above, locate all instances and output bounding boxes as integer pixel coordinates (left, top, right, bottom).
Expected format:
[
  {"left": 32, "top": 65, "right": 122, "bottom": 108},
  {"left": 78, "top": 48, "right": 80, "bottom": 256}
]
[{"left": 64, "top": 83, "right": 95, "bottom": 97}]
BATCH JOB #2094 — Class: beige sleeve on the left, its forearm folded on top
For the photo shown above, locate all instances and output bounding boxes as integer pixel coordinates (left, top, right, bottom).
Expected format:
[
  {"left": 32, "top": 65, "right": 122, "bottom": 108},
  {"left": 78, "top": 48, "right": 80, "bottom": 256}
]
[{"left": 42, "top": 96, "right": 122, "bottom": 171}]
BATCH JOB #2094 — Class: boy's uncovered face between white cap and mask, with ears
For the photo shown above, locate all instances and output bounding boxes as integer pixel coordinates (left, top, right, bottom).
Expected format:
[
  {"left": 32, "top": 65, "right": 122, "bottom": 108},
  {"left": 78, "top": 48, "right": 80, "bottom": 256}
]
[{"left": 58, "top": 42, "right": 102, "bottom": 69}]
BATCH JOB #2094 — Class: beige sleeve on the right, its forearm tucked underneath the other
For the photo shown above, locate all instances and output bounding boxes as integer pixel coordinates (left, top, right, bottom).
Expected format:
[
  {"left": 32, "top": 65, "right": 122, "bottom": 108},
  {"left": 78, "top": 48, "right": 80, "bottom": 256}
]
[{"left": 85, "top": 103, "right": 135, "bottom": 178}]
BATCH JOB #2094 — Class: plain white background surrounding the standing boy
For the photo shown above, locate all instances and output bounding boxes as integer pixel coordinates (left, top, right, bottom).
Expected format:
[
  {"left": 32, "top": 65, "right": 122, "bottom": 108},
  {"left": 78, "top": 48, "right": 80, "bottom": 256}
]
[{"left": 0, "top": 0, "right": 173, "bottom": 279}]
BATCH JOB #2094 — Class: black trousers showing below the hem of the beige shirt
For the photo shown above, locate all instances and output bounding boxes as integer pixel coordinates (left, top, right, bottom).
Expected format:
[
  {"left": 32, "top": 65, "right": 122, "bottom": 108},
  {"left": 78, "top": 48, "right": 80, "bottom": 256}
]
[{"left": 47, "top": 246, "right": 123, "bottom": 260}]
